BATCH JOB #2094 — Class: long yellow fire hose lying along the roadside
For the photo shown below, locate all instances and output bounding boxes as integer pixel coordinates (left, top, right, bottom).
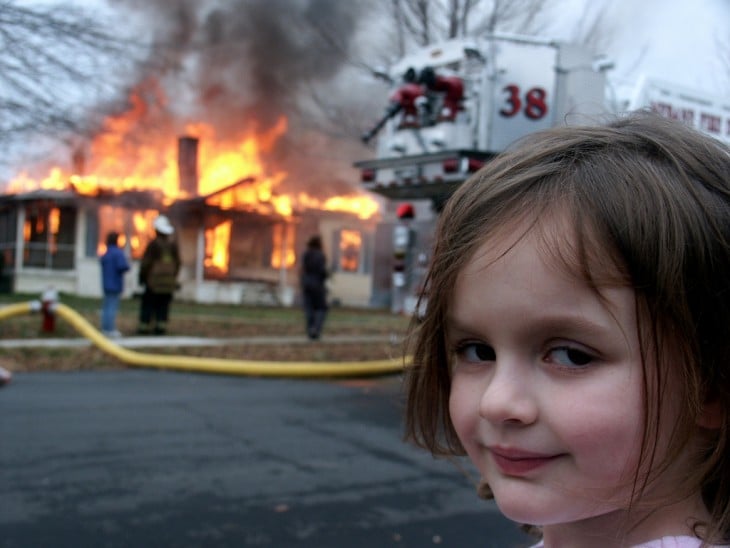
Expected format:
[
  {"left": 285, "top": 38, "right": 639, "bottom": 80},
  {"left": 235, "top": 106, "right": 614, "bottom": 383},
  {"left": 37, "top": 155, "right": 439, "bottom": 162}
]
[{"left": 0, "top": 301, "right": 404, "bottom": 377}]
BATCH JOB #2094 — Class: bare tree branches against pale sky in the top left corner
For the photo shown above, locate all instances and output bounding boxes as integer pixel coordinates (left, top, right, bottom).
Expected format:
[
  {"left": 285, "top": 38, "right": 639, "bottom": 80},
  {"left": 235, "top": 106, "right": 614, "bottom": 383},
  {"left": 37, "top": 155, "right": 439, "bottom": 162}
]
[{"left": 0, "top": 0, "right": 139, "bottom": 148}]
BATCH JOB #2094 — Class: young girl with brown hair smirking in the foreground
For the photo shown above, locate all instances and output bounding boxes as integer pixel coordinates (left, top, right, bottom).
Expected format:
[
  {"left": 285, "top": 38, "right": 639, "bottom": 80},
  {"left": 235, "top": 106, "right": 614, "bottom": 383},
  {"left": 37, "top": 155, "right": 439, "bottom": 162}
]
[{"left": 406, "top": 113, "right": 730, "bottom": 548}]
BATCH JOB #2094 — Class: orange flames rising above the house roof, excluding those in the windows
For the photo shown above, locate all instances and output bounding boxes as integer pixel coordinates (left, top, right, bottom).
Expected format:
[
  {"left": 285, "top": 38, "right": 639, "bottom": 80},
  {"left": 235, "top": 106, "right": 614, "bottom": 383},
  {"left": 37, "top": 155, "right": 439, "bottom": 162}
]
[{"left": 7, "top": 93, "right": 379, "bottom": 219}]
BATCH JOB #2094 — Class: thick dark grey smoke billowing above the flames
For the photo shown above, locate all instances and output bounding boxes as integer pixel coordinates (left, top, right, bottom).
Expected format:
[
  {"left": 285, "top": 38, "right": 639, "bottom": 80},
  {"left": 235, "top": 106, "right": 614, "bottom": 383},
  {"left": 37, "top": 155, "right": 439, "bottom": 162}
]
[{"left": 102, "top": 0, "right": 378, "bottom": 194}]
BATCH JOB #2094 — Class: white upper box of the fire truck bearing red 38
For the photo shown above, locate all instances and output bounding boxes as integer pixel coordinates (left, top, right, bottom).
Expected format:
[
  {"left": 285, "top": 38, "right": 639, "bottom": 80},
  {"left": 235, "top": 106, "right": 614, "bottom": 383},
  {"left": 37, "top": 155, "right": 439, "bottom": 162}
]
[{"left": 356, "top": 35, "right": 608, "bottom": 203}]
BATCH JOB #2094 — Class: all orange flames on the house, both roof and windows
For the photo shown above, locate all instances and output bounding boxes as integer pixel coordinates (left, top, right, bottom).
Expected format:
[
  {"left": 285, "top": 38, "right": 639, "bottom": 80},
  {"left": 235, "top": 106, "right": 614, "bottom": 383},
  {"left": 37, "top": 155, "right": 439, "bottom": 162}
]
[{"left": 7, "top": 82, "right": 379, "bottom": 278}]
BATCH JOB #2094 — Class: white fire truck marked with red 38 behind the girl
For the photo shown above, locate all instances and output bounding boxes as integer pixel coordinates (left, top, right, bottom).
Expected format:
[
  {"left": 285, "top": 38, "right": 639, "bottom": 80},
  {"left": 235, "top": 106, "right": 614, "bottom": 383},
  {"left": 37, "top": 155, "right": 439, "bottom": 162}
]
[{"left": 355, "top": 34, "right": 730, "bottom": 312}]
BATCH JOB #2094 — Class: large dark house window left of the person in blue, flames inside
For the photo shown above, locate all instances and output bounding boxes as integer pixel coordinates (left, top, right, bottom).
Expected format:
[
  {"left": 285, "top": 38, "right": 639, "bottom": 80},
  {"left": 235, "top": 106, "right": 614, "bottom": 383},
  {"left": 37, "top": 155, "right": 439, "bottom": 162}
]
[{"left": 23, "top": 202, "right": 76, "bottom": 270}]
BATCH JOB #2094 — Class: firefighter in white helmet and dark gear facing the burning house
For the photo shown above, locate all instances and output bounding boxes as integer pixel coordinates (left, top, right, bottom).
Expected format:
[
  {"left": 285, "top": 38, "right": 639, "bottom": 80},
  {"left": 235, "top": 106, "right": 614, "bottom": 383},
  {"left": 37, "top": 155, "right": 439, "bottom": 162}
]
[{"left": 137, "top": 215, "right": 180, "bottom": 335}]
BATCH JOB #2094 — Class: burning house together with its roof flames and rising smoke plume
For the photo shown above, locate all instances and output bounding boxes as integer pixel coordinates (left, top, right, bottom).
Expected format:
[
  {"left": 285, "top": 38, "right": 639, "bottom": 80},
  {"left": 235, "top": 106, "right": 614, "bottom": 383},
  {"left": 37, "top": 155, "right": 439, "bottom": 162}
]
[{"left": 0, "top": 0, "right": 391, "bottom": 306}]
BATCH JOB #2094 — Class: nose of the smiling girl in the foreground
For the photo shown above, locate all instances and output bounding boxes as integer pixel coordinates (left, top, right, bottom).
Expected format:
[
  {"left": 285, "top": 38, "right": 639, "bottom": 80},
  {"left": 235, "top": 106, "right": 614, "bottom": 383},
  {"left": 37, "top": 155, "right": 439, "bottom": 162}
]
[{"left": 479, "top": 358, "right": 538, "bottom": 425}]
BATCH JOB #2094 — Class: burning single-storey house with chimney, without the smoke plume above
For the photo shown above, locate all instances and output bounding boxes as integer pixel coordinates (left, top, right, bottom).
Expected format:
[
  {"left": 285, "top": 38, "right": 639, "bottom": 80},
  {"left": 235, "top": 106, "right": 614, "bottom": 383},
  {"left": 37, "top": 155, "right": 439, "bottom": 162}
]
[{"left": 0, "top": 130, "right": 378, "bottom": 306}]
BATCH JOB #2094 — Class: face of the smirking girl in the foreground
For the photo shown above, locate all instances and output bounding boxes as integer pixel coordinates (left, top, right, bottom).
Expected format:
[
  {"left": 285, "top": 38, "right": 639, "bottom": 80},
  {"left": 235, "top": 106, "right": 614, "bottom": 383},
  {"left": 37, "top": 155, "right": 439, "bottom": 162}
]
[{"left": 447, "top": 220, "right": 696, "bottom": 538}]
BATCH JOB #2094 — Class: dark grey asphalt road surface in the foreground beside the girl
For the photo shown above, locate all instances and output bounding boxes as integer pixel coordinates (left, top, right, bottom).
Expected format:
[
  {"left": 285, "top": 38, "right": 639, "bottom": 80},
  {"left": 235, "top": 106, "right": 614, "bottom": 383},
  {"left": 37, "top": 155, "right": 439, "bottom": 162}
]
[{"left": 0, "top": 370, "right": 530, "bottom": 548}]
